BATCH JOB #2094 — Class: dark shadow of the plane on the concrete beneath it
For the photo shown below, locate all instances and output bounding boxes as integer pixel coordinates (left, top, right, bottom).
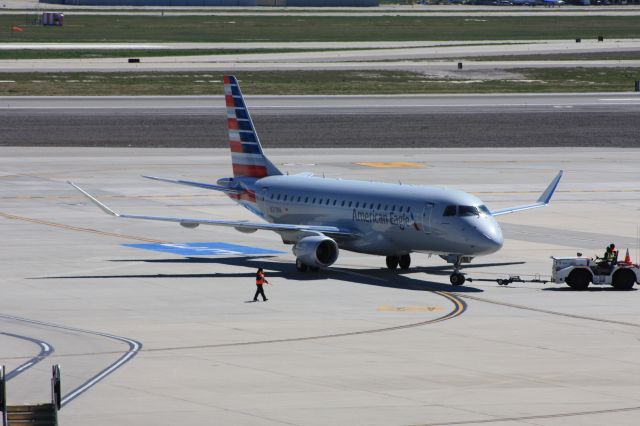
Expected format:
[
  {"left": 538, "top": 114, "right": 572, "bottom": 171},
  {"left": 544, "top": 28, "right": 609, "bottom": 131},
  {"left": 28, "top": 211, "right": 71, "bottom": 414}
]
[{"left": 32, "top": 256, "right": 524, "bottom": 293}]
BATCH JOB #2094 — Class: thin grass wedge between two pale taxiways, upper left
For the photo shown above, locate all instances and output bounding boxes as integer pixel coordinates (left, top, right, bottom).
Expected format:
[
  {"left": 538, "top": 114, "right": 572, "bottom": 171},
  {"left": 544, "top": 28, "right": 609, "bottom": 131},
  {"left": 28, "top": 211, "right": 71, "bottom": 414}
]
[{"left": 0, "top": 49, "right": 317, "bottom": 60}]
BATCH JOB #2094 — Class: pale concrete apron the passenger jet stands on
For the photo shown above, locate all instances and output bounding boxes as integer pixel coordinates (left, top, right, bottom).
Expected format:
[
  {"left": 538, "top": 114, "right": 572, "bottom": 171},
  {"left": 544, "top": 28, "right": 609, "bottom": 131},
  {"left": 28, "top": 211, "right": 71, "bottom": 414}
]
[{"left": 0, "top": 147, "right": 640, "bottom": 426}]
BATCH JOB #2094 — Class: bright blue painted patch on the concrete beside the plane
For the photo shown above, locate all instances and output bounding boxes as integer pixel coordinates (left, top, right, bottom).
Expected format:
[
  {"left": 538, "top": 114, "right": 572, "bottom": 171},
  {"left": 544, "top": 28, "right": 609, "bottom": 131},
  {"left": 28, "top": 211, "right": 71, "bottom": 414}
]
[{"left": 123, "top": 242, "right": 285, "bottom": 256}]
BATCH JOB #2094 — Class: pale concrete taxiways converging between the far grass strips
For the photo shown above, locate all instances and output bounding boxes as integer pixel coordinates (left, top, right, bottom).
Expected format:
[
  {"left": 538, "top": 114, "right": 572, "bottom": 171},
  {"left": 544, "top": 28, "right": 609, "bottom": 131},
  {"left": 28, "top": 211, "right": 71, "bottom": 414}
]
[{"left": 0, "top": 38, "right": 640, "bottom": 73}]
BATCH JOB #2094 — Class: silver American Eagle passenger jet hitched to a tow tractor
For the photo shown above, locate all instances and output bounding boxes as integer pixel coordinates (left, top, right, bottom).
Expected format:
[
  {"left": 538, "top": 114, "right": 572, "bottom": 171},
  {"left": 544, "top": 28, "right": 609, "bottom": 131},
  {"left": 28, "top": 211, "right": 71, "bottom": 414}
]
[{"left": 69, "top": 75, "right": 563, "bottom": 285}]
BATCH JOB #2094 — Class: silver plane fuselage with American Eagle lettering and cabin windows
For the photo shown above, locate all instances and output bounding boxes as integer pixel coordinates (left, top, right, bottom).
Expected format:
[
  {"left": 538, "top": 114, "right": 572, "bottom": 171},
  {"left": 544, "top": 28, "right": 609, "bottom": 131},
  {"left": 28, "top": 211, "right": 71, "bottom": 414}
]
[{"left": 248, "top": 176, "right": 503, "bottom": 256}]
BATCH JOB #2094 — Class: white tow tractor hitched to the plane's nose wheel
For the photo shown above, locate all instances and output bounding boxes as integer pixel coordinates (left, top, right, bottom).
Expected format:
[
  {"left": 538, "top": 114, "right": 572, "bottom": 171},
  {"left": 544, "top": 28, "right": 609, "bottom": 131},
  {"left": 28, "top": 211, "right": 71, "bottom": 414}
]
[{"left": 551, "top": 256, "right": 640, "bottom": 290}]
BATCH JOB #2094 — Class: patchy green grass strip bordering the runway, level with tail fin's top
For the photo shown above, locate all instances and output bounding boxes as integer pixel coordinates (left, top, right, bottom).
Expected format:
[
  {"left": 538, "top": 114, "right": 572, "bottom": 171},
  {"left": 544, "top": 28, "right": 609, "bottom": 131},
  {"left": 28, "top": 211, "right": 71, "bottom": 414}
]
[{"left": 0, "top": 68, "right": 640, "bottom": 96}]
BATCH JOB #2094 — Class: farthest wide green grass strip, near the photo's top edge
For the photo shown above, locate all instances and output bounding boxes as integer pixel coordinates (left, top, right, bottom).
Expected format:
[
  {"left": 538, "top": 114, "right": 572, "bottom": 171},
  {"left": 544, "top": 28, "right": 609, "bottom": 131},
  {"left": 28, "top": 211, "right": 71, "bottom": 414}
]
[{"left": 0, "top": 15, "right": 640, "bottom": 42}]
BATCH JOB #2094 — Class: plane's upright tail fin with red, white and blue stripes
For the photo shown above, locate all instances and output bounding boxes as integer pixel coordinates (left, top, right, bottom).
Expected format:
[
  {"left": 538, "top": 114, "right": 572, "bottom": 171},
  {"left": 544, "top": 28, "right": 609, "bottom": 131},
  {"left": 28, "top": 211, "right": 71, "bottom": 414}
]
[{"left": 224, "top": 75, "right": 282, "bottom": 179}]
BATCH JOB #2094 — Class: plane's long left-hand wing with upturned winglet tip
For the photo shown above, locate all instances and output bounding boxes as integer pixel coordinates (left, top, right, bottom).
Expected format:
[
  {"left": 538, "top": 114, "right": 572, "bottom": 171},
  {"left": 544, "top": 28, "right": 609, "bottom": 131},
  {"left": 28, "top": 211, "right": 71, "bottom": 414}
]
[{"left": 68, "top": 182, "right": 360, "bottom": 238}]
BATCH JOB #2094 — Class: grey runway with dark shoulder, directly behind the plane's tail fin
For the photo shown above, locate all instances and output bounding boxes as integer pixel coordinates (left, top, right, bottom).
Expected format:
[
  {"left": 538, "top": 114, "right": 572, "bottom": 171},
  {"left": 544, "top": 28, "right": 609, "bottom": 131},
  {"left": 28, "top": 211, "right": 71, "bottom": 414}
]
[{"left": 0, "top": 93, "right": 640, "bottom": 148}]
